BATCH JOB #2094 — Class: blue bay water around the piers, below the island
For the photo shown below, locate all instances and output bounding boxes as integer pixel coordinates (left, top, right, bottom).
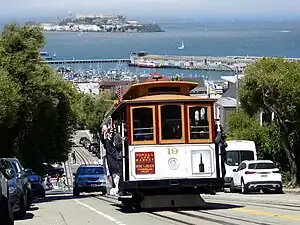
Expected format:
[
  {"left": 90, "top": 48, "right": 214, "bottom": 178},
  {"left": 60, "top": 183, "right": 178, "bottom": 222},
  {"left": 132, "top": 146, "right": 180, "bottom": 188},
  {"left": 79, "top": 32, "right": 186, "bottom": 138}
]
[{"left": 0, "top": 21, "right": 300, "bottom": 79}]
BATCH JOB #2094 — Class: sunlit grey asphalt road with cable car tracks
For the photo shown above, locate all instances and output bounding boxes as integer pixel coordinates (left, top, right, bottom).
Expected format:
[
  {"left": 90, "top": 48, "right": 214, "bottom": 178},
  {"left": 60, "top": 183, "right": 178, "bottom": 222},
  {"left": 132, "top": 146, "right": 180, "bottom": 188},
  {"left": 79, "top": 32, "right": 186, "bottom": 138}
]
[{"left": 16, "top": 131, "right": 300, "bottom": 225}]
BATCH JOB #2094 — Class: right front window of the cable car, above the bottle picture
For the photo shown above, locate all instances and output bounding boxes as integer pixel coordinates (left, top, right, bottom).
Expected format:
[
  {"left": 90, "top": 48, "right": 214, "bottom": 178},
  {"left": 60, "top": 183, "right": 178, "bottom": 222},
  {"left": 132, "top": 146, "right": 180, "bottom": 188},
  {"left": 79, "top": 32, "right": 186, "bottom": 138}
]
[{"left": 189, "top": 106, "right": 209, "bottom": 139}]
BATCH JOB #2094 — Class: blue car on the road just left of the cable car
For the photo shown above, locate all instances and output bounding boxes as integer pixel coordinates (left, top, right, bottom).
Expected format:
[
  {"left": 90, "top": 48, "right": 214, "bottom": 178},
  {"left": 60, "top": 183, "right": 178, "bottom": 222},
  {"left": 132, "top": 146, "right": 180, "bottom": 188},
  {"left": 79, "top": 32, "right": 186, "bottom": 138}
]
[{"left": 73, "top": 165, "right": 106, "bottom": 196}]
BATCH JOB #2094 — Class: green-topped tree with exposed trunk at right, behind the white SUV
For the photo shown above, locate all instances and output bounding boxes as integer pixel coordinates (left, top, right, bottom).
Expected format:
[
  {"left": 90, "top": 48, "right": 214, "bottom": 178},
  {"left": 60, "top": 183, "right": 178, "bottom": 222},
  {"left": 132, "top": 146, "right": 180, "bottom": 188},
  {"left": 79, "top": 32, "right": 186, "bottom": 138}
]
[{"left": 239, "top": 59, "right": 300, "bottom": 186}]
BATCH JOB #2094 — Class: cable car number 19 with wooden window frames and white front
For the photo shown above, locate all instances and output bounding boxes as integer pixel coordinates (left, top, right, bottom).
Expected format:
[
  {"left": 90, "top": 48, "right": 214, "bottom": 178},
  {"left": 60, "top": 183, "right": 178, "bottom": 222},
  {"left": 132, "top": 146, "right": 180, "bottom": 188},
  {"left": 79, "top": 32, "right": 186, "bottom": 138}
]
[{"left": 104, "top": 74, "right": 226, "bottom": 211}]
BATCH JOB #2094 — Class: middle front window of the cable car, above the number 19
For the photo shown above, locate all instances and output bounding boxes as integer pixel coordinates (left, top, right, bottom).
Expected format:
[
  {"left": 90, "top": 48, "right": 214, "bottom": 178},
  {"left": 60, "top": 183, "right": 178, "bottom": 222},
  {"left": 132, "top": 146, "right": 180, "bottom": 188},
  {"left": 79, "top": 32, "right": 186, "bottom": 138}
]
[{"left": 160, "top": 105, "right": 182, "bottom": 140}]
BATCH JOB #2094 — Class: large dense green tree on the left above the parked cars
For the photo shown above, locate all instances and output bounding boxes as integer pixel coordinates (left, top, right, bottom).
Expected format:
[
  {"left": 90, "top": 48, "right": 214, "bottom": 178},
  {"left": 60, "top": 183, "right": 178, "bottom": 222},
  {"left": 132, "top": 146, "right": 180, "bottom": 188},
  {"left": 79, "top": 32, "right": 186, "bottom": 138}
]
[{"left": 0, "top": 25, "right": 77, "bottom": 171}]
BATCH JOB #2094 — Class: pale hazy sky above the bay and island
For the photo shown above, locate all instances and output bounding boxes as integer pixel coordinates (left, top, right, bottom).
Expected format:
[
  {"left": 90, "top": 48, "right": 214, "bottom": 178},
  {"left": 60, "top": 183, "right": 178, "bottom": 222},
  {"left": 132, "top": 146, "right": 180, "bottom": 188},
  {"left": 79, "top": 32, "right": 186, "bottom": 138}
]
[{"left": 0, "top": 0, "right": 300, "bottom": 20}]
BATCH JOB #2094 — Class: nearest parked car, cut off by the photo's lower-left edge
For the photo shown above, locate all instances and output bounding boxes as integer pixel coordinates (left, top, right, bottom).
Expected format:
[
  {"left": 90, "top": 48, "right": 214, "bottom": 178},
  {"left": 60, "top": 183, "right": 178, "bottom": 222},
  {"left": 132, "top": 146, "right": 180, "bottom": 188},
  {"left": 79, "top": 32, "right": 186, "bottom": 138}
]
[{"left": 0, "top": 158, "right": 14, "bottom": 225}]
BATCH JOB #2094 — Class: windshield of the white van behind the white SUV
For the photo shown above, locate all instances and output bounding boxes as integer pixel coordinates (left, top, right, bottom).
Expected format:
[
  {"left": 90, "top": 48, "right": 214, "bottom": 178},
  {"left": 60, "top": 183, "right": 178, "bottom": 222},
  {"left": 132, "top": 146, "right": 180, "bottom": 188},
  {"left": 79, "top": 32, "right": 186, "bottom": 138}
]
[{"left": 226, "top": 150, "right": 254, "bottom": 166}]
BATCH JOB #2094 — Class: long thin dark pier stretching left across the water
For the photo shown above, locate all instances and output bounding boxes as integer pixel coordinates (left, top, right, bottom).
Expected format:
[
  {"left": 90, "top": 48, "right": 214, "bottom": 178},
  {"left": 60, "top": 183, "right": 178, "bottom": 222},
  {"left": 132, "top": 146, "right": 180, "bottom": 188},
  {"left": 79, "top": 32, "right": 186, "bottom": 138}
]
[{"left": 43, "top": 59, "right": 130, "bottom": 65}]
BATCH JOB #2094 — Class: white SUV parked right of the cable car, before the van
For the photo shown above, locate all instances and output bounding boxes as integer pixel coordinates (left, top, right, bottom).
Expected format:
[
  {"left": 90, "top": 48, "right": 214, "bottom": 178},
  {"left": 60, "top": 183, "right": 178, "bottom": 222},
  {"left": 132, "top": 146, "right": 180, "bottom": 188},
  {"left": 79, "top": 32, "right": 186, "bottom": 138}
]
[{"left": 230, "top": 160, "right": 282, "bottom": 193}]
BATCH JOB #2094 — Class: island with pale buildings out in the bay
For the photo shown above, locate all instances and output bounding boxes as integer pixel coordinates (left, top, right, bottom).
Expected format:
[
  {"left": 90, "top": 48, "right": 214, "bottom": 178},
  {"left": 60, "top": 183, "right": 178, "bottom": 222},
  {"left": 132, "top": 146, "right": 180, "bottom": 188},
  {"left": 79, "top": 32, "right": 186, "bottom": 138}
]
[{"left": 40, "top": 14, "right": 164, "bottom": 33}]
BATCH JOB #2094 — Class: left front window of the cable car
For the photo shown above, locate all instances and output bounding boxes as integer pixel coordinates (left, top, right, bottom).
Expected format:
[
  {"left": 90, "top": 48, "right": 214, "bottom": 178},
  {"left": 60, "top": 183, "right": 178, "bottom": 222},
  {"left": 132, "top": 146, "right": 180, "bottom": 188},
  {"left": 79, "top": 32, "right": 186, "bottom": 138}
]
[{"left": 132, "top": 108, "right": 154, "bottom": 141}]
